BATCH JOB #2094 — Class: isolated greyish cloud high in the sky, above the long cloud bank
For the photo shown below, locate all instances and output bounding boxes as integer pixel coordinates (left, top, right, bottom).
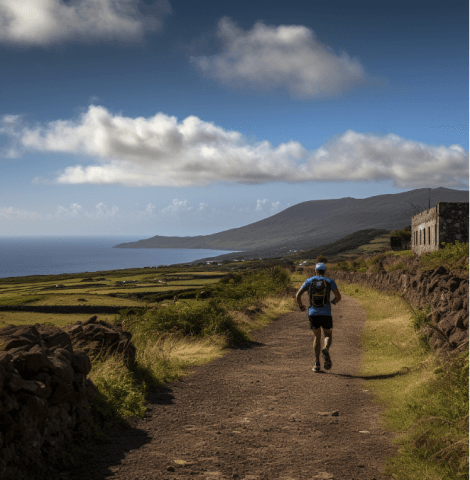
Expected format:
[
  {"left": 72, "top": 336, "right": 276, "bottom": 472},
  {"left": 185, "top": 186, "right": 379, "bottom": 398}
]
[{"left": 191, "top": 17, "right": 367, "bottom": 98}]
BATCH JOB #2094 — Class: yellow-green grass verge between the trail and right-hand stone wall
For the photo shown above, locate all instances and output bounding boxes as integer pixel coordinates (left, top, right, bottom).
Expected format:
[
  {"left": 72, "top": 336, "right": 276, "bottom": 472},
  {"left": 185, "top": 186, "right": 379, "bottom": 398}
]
[{"left": 341, "top": 285, "right": 469, "bottom": 480}]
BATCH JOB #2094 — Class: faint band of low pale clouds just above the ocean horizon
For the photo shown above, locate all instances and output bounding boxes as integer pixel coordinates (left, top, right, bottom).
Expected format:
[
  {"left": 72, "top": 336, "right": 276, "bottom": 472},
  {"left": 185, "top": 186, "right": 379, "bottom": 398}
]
[{"left": 0, "top": 198, "right": 286, "bottom": 235}]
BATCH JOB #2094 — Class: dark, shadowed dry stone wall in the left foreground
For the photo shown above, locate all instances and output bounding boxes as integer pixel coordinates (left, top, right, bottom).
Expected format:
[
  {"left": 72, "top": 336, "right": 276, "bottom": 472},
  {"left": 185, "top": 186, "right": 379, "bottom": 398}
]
[{"left": 0, "top": 316, "right": 136, "bottom": 478}]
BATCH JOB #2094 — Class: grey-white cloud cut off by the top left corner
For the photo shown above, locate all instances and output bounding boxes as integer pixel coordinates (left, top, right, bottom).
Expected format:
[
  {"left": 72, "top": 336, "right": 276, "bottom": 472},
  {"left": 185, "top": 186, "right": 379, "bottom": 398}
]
[{"left": 0, "top": 0, "right": 171, "bottom": 46}]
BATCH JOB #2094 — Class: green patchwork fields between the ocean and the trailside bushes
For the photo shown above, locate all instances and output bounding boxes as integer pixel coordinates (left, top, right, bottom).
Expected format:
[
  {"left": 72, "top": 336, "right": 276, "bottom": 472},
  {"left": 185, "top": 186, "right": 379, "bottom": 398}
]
[{"left": 0, "top": 266, "right": 230, "bottom": 327}]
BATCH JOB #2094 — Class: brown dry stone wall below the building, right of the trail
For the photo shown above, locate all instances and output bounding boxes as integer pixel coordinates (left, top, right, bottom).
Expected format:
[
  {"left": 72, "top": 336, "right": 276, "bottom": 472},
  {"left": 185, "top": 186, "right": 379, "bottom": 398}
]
[{"left": 331, "top": 267, "right": 469, "bottom": 349}]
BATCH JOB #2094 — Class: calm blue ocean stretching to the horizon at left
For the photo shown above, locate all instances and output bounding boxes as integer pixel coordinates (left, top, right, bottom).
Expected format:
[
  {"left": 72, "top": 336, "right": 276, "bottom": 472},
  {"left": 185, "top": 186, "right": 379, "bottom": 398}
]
[{"left": 0, "top": 236, "right": 235, "bottom": 278}]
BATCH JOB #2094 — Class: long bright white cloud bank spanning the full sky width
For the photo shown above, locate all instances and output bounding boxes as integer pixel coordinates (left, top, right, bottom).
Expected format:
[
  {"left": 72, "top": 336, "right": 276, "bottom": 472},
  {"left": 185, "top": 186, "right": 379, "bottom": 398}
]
[{"left": 0, "top": 106, "right": 468, "bottom": 188}]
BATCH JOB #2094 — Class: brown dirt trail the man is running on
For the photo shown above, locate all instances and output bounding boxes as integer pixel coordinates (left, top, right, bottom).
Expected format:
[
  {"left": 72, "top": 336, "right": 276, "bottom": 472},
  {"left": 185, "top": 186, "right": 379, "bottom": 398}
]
[{"left": 73, "top": 296, "right": 395, "bottom": 480}]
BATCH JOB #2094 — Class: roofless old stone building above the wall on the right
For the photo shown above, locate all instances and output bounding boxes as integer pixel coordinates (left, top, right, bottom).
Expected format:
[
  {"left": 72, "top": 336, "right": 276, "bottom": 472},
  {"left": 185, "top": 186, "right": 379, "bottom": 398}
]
[{"left": 411, "top": 202, "right": 468, "bottom": 255}]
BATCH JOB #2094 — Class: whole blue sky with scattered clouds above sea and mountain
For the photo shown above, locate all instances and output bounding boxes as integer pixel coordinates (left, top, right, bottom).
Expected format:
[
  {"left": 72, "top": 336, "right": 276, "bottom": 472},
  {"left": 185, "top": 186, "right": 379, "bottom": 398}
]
[{"left": 0, "top": 0, "right": 469, "bottom": 237}]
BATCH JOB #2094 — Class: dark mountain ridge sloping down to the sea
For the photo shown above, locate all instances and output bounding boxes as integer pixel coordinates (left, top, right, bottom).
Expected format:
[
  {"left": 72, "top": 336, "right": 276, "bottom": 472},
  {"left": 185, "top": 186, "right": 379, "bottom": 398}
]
[{"left": 114, "top": 187, "right": 468, "bottom": 256}]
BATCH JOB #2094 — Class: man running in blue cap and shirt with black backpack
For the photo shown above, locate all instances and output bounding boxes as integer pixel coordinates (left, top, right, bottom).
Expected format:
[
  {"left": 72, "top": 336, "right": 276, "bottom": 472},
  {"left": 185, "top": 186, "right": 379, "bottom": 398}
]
[{"left": 295, "top": 263, "right": 341, "bottom": 372}]
